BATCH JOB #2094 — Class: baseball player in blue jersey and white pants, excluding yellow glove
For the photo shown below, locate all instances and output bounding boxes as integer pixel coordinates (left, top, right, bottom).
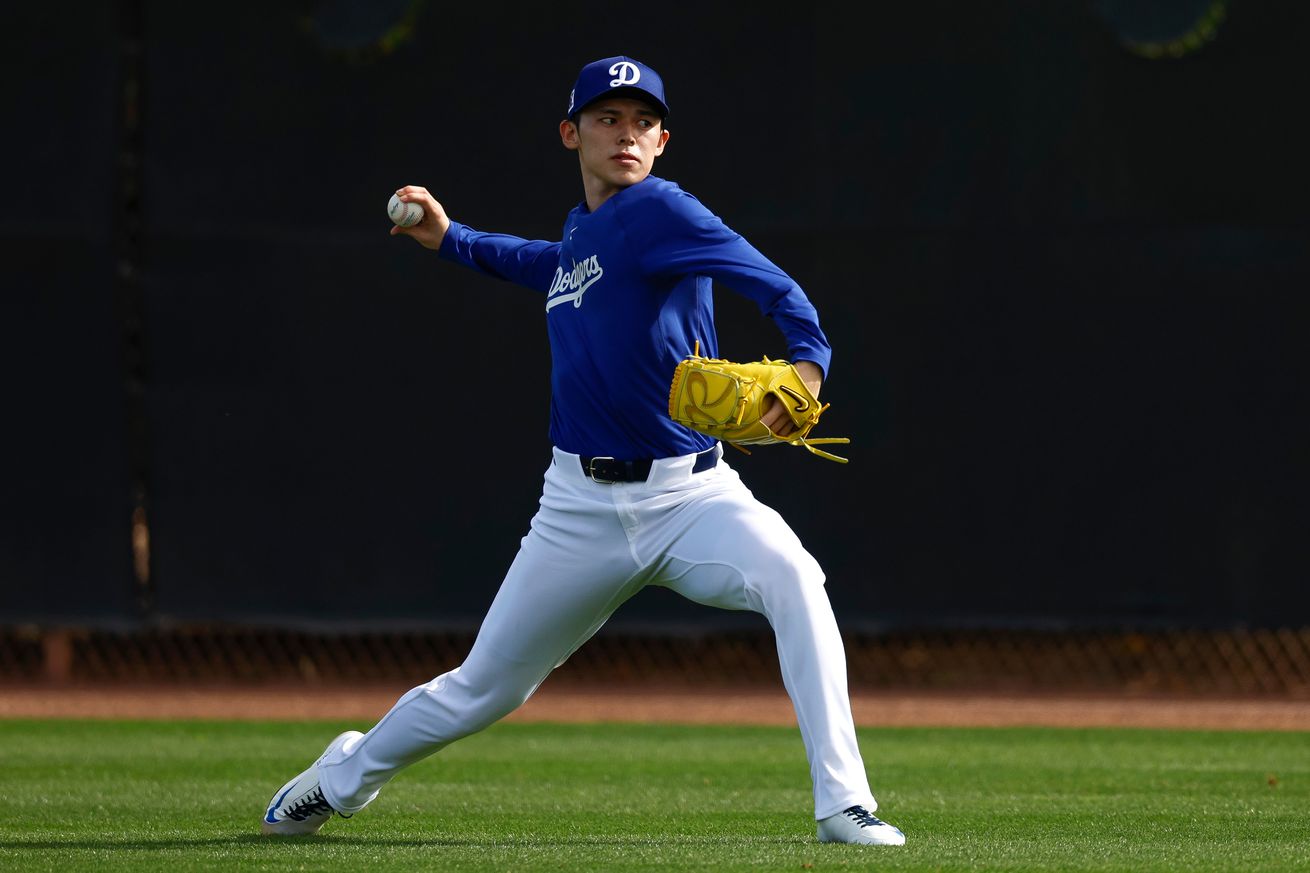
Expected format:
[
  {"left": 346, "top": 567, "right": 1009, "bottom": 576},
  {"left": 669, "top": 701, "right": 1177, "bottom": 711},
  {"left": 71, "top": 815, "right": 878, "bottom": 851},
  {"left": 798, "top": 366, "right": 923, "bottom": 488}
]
[{"left": 262, "top": 56, "right": 905, "bottom": 845}]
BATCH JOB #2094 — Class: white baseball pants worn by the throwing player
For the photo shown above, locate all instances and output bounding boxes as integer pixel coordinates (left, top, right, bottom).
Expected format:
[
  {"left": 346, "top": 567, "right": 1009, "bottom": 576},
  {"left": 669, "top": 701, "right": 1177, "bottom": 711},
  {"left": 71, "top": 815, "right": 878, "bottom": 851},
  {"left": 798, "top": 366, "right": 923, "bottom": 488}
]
[{"left": 320, "top": 447, "right": 876, "bottom": 818}]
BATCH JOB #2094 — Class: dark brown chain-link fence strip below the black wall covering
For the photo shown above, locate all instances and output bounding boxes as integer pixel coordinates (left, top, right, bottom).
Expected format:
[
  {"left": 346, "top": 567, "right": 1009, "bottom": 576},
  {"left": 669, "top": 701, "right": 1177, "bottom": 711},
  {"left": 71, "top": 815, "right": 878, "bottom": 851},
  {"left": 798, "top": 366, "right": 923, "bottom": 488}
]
[{"left": 0, "top": 627, "right": 1310, "bottom": 696}]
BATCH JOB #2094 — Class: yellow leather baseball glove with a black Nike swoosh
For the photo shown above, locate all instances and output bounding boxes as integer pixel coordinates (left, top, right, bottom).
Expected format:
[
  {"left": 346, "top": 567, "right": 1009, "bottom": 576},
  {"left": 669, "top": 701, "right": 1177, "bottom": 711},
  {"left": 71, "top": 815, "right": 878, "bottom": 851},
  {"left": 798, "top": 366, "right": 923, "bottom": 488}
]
[{"left": 668, "top": 343, "right": 850, "bottom": 464}]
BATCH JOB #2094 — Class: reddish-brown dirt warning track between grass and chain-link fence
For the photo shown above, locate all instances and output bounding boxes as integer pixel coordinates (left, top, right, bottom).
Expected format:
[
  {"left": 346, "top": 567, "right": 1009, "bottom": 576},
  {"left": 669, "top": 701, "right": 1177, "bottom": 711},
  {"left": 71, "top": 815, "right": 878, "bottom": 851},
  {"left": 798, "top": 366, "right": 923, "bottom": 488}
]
[{"left": 0, "top": 686, "right": 1310, "bottom": 730}]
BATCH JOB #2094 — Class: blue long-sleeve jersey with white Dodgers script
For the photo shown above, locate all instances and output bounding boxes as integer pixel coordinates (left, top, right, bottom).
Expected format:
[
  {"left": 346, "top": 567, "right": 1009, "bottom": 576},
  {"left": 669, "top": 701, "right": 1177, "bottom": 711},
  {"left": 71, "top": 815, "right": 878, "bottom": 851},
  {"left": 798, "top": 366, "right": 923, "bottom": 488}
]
[{"left": 440, "top": 176, "right": 832, "bottom": 460}]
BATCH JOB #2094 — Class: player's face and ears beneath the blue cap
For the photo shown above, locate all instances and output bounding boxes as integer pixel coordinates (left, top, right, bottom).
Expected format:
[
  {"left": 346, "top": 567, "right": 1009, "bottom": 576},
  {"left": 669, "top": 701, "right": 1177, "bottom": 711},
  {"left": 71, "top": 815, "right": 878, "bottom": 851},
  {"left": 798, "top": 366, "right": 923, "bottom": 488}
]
[{"left": 561, "top": 97, "right": 668, "bottom": 199}]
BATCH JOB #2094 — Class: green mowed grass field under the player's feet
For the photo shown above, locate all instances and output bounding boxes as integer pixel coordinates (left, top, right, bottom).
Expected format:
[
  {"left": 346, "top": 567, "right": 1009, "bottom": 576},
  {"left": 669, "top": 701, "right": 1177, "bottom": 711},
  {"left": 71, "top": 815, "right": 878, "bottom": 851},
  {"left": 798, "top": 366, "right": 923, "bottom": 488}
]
[{"left": 0, "top": 720, "right": 1310, "bottom": 873}]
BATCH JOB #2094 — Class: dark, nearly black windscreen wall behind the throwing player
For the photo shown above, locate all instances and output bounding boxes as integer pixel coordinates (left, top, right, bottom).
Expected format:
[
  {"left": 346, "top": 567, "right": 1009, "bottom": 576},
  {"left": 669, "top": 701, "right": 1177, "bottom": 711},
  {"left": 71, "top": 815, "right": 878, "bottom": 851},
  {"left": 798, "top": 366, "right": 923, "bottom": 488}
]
[{"left": 0, "top": 0, "right": 1310, "bottom": 627}]
